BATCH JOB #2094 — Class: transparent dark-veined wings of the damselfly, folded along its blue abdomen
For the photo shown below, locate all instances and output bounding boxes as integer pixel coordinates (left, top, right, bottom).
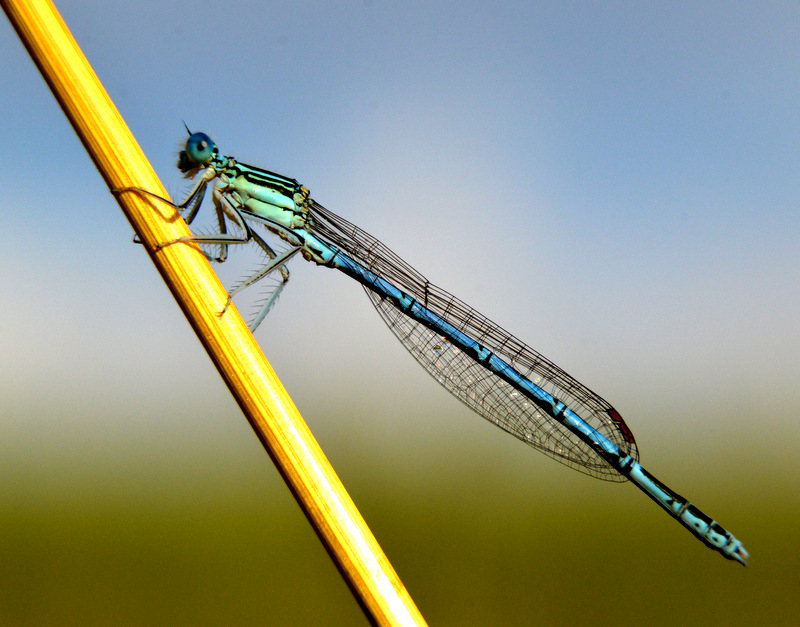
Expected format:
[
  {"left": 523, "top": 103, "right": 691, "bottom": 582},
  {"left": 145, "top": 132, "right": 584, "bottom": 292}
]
[{"left": 309, "top": 201, "right": 638, "bottom": 482}]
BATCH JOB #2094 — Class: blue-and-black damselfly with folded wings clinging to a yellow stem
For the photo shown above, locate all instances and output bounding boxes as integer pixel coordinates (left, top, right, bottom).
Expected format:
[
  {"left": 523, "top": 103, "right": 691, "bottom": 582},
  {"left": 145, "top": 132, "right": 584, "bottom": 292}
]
[{"left": 118, "top": 129, "right": 748, "bottom": 564}]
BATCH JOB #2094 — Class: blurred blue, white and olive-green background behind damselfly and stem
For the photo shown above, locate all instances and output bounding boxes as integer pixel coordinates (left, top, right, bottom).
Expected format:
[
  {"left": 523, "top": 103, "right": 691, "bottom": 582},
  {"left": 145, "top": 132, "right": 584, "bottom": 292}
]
[{"left": 0, "top": 0, "right": 800, "bottom": 625}]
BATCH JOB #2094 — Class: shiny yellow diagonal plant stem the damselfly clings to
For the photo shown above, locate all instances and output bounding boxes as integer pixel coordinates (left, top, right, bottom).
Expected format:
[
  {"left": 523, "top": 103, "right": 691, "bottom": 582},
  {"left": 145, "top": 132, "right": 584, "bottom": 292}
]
[{"left": 0, "top": 0, "right": 425, "bottom": 625}]
